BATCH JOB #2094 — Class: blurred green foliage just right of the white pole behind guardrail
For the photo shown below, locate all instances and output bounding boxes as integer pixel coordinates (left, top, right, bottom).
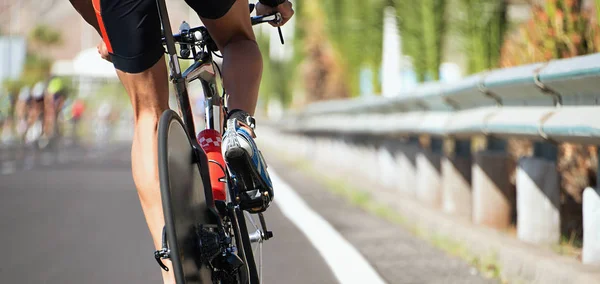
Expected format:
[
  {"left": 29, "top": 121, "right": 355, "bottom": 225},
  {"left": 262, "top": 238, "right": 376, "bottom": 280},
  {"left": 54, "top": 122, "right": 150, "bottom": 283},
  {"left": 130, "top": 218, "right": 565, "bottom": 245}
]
[{"left": 396, "top": 0, "right": 448, "bottom": 82}]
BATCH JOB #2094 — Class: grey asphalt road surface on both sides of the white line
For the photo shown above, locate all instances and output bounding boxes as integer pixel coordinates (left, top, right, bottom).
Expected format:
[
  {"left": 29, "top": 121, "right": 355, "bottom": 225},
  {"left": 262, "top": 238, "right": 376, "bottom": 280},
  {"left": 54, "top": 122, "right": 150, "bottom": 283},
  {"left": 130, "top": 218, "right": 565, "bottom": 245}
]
[{"left": 0, "top": 139, "right": 486, "bottom": 284}]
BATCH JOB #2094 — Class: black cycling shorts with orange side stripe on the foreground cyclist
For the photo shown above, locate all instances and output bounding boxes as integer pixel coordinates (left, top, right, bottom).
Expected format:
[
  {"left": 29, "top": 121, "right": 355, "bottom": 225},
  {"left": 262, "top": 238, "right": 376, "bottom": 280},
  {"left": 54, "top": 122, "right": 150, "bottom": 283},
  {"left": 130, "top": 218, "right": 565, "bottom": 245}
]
[{"left": 91, "top": 0, "right": 236, "bottom": 73}]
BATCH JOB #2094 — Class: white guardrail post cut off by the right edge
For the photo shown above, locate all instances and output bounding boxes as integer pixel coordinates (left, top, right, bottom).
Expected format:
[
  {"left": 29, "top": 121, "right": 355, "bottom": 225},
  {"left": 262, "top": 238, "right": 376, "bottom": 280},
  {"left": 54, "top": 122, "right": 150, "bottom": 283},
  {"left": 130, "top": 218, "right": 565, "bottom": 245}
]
[{"left": 582, "top": 188, "right": 600, "bottom": 266}]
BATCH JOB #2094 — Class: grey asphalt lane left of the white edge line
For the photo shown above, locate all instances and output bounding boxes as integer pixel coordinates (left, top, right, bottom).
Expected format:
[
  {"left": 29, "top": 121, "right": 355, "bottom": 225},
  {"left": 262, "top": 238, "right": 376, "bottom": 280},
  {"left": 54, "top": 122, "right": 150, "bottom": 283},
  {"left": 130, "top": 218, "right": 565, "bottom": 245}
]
[{"left": 0, "top": 142, "right": 336, "bottom": 284}]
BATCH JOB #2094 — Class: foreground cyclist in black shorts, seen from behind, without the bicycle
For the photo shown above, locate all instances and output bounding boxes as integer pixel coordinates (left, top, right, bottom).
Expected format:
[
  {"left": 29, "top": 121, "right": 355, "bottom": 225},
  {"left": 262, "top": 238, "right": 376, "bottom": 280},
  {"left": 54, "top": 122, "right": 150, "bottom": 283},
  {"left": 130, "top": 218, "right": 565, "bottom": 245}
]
[{"left": 70, "top": 0, "right": 294, "bottom": 282}]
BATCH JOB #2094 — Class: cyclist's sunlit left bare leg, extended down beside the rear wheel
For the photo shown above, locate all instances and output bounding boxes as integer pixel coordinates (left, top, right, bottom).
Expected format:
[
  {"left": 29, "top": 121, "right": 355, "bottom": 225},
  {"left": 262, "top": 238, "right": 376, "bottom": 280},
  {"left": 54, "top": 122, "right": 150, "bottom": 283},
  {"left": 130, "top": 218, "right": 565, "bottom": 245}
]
[{"left": 117, "top": 59, "right": 175, "bottom": 283}]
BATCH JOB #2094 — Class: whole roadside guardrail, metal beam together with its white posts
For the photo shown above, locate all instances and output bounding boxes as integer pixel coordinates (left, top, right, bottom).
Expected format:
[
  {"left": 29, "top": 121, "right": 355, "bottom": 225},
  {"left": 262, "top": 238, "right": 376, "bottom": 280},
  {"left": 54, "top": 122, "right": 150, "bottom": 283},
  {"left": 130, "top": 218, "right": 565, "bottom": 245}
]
[{"left": 276, "top": 54, "right": 600, "bottom": 270}]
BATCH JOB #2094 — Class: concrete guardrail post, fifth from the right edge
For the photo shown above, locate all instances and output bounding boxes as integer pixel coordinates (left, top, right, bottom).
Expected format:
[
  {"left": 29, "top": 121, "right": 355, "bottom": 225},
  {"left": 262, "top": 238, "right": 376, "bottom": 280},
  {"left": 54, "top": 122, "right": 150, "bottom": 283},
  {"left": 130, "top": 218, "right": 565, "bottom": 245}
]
[{"left": 417, "top": 139, "right": 442, "bottom": 208}]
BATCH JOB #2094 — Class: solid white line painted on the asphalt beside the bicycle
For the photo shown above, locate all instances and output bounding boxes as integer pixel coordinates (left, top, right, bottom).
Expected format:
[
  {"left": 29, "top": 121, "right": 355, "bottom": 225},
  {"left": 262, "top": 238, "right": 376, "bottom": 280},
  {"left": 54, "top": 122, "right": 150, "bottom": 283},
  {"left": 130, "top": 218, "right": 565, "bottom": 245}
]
[{"left": 269, "top": 169, "right": 385, "bottom": 284}]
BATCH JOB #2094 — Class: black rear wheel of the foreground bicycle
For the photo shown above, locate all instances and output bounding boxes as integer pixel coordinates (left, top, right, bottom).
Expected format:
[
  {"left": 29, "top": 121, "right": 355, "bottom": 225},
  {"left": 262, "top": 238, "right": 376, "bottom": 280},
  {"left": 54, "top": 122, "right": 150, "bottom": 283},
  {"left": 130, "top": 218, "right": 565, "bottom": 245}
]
[{"left": 158, "top": 110, "right": 218, "bottom": 284}]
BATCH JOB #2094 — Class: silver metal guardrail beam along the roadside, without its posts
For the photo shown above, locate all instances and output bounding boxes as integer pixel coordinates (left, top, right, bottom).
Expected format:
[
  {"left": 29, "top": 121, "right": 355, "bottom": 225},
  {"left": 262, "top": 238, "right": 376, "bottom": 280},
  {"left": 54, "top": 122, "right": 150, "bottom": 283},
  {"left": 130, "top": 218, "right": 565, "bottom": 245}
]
[{"left": 282, "top": 54, "right": 600, "bottom": 144}]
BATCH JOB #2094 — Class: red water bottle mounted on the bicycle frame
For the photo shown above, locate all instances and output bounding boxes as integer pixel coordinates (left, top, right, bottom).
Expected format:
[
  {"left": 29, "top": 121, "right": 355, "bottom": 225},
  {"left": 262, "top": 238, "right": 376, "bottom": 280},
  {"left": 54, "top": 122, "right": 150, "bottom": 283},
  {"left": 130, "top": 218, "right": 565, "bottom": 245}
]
[{"left": 198, "top": 129, "right": 227, "bottom": 201}]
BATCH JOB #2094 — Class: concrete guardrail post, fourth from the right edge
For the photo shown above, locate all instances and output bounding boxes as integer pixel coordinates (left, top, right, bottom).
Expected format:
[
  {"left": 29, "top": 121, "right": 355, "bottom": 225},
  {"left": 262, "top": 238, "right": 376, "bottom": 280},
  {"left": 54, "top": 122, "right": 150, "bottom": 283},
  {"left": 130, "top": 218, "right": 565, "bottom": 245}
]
[{"left": 442, "top": 141, "right": 472, "bottom": 221}]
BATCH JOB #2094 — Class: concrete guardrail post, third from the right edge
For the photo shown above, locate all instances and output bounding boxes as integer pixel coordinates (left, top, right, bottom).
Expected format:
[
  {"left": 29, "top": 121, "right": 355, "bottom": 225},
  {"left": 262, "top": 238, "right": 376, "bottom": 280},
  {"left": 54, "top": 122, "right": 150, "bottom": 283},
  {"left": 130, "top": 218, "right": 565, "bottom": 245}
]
[{"left": 472, "top": 141, "right": 515, "bottom": 229}]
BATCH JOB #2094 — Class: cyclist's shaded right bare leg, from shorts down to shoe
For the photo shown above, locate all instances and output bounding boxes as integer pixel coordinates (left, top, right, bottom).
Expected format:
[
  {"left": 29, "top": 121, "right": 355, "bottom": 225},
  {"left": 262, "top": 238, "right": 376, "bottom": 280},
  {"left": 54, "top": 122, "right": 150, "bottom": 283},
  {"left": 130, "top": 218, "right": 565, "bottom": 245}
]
[{"left": 202, "top": 0, "right": 263, "bottom": 115}]
